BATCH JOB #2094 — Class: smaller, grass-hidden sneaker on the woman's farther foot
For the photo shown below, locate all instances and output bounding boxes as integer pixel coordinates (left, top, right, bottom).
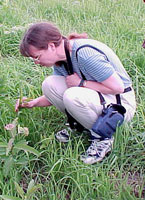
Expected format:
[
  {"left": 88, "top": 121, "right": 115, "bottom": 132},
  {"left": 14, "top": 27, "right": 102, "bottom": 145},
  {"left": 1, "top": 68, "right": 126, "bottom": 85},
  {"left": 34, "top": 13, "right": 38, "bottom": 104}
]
[{"left": 55, "top": 128, "right": 72, "bottom": 143}]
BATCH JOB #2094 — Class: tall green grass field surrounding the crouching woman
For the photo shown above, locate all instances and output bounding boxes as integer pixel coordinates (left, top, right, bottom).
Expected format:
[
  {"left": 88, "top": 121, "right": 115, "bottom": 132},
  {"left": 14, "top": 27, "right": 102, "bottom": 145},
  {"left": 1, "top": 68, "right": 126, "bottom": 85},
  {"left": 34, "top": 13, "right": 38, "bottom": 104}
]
[{"left": 0, "top": 0, "right": 145, "bottom": 200}]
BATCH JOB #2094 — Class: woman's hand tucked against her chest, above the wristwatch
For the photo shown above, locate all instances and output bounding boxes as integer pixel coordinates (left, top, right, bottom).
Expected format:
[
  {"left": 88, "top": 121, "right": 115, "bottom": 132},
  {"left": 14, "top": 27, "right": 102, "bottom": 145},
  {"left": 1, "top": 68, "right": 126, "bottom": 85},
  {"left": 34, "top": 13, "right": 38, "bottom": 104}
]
[{"left": 66, "top": 73, "right": 81, "bottom": 88}]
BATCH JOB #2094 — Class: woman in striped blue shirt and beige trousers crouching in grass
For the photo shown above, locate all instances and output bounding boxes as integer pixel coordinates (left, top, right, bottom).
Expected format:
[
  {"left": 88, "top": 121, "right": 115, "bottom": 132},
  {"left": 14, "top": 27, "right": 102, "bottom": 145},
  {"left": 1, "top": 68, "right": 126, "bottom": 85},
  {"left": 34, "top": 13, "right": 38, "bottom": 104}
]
[{"left": 15, "top": 22, "right": 136, "bottom": 164}]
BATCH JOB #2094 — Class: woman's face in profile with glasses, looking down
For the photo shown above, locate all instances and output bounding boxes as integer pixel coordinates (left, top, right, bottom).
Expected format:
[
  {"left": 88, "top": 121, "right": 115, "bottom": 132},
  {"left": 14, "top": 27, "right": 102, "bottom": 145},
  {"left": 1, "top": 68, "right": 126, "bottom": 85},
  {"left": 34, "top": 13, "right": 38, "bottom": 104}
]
[{"left": 29, "top": 43, "right": 57, "bottom": 67}]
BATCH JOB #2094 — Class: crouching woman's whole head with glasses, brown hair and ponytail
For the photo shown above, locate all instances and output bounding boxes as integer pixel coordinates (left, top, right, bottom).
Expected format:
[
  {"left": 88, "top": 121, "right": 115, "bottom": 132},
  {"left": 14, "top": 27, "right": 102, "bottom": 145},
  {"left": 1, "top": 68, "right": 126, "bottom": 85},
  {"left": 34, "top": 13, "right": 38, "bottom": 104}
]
[{"left": 20, "top": 22, "right": 87, "bottom": 67}]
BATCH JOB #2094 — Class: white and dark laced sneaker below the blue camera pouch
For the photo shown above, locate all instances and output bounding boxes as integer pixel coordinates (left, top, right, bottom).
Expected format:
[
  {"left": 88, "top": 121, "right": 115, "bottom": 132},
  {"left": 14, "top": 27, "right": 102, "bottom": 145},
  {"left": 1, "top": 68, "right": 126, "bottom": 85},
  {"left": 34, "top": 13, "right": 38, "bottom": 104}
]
[{"left": 81, "top": 137, "right": 114, "bottom": 164}]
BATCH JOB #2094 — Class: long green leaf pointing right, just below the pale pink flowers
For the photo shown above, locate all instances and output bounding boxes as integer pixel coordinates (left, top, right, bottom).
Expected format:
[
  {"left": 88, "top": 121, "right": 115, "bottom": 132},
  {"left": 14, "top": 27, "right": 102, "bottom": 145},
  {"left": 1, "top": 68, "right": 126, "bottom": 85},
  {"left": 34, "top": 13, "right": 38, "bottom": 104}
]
[{"left": 14, "top": 144, "right": 40, "bottom": 156}]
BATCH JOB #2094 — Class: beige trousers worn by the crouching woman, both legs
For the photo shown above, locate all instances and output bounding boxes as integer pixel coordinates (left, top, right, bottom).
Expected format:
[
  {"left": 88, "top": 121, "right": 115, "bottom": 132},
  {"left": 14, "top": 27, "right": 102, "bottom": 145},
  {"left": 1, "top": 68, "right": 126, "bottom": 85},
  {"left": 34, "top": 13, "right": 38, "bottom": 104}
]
[{"left": 42, "top": 75, "right": 136, "bottom": 129}]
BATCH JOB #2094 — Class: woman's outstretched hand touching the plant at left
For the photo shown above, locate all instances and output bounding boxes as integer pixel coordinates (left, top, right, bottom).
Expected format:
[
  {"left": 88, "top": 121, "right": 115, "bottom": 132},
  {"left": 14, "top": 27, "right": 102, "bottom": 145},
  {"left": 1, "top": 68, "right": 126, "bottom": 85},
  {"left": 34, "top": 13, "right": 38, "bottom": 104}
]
[{"left": 15, "top": 97, "right": 35, "bottom": 112}]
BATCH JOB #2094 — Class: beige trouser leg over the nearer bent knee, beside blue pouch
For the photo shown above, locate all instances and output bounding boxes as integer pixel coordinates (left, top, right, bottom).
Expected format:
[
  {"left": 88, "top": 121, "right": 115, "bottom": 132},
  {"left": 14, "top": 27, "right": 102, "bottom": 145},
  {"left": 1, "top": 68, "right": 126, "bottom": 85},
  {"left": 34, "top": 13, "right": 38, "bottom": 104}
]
[{"left": 63, "top": 87, "right": 102, "bottom": 129}]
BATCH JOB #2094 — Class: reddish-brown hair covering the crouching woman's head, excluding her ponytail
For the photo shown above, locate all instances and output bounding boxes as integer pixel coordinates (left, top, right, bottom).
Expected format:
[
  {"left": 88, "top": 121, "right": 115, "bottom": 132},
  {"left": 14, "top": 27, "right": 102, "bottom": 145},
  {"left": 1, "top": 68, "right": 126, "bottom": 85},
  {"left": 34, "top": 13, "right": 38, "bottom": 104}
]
[{"left": 20, "top": 22, "right": 63, "bottom": 57}]
